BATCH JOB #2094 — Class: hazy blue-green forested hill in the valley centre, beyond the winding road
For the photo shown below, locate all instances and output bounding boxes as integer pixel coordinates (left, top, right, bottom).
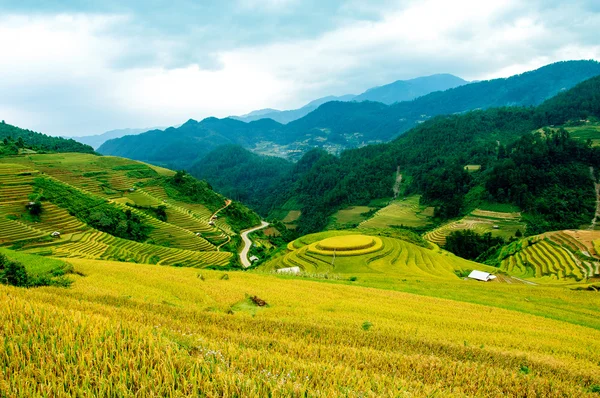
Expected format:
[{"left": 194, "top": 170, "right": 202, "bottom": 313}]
[{"left": 190, "top": 145, "right": 293, "bottom": 208}]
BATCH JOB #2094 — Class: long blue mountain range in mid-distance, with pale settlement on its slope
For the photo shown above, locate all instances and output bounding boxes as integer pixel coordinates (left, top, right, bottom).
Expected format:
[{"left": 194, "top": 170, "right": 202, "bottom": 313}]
[{"left": 98, "top": 61, "right": 600, "bottom": 168}]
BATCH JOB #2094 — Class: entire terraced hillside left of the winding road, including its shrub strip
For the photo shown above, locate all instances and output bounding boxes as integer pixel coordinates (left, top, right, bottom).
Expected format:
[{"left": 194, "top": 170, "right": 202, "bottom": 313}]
[{"left": 0, "top": 153, "right": 259, "bottom": 267}]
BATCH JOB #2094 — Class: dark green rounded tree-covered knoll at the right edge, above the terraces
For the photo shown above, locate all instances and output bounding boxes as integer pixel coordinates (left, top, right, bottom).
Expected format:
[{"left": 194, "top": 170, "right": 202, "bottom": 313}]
[{"left": 485, "top": 129, "right": 600, "bottom": 234}]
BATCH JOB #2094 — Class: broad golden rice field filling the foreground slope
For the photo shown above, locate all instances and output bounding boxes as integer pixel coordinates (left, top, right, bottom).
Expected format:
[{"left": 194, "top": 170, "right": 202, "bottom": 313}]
[{"left": 0, "top": 259, "right": 600, "bottom": 397}]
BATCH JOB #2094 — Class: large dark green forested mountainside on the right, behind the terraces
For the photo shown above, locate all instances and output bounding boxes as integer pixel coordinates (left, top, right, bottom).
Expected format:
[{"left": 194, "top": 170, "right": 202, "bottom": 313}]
[{"left": 224, "top": 77, "right": 600, "bottom": 233}]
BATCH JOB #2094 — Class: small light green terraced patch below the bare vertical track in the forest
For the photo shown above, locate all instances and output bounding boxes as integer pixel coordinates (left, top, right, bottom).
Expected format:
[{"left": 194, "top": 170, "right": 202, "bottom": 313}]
[{"left": 359, "top": 195, "right": 432, "bottom": 229}]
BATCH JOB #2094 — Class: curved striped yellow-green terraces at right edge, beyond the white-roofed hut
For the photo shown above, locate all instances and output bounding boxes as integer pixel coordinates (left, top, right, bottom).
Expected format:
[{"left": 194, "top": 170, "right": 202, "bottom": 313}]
[{"left": 501, "top": 231, "right": 600, "bottom": 282}]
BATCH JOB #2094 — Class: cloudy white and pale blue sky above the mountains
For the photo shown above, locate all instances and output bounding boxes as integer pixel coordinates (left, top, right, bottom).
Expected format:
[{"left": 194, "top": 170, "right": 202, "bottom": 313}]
[{"left": 0, "top": 0, "right": 600, "bottom": 136}]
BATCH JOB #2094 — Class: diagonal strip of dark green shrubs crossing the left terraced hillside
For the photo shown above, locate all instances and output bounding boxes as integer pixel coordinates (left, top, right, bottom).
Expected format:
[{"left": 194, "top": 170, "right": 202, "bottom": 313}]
[{"left": 34, "top": 178, "right": 152, "bottom": 242}]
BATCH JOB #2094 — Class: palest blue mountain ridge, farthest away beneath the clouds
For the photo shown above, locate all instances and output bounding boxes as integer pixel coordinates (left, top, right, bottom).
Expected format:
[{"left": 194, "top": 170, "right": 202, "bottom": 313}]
[{"left": 231, "top": 73, "right": 469, "bottom": 124}]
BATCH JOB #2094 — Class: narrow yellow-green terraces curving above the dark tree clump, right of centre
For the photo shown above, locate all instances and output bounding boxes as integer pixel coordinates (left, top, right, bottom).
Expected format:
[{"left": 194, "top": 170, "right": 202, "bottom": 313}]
[{"left": 424, "top": 209, "right": 525, "bottom": 246}]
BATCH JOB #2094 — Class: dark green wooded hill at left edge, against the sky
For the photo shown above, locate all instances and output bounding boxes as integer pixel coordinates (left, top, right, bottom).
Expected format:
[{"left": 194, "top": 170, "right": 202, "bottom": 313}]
[{"left": 0, "top": 120, "right": 94, "bottom": 155}]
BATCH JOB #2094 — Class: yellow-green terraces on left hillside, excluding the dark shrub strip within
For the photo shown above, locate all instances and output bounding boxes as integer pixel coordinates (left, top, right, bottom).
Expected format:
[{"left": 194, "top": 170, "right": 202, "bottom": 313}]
[{"left": 0, "top": 153, "right": 235, "bottom": 267}]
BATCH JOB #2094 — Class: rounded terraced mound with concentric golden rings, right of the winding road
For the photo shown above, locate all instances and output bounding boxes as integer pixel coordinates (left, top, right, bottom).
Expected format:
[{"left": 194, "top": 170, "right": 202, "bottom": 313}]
[{"left": 262, "top": 230, "right": 496, "bottom": 279}]
